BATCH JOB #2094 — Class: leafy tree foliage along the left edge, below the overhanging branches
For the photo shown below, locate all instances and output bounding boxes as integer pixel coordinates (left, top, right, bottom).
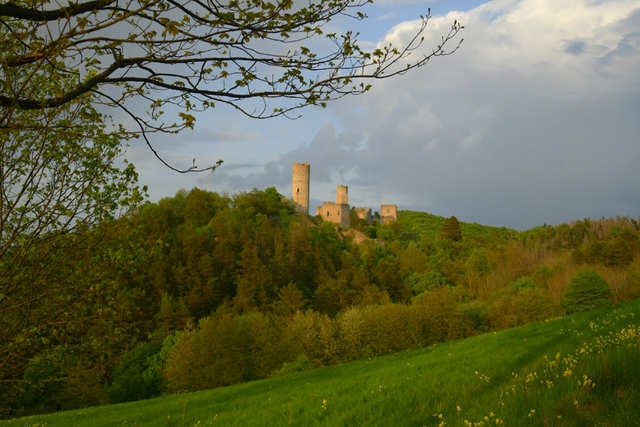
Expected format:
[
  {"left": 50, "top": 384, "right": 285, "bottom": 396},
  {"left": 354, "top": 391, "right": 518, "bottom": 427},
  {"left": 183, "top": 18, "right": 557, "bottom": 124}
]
[{"left": 0, "top": 84, "right": 145, "bottom": 414}]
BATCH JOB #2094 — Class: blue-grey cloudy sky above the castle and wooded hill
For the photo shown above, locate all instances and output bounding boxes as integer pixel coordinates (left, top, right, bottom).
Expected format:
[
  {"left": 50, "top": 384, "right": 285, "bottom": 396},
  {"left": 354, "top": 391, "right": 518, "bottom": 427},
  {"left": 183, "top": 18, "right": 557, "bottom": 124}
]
[{"left": 120, "top": 0, "right": 640, "bottom": 230}]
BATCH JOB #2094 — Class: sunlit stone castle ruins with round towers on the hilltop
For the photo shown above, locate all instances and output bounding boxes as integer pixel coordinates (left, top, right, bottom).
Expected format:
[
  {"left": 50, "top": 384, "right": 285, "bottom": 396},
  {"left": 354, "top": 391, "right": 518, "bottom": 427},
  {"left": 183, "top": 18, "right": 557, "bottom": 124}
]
[{"left": 292, "top": 162, "right": 398, "bottom": 229}]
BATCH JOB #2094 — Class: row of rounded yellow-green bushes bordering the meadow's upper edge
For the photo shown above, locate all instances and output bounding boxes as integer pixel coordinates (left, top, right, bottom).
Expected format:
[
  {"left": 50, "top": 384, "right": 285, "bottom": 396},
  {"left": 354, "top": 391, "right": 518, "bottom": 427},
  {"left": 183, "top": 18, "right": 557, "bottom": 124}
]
[{"left": 159, "top": 288, "right": 473, "bottom": 391}]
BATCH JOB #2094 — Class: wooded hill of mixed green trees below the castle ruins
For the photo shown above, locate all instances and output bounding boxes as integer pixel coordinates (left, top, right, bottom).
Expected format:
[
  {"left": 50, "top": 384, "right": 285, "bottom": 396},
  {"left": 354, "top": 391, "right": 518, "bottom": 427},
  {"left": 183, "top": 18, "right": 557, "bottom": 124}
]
[{"left": 5, "top": 188, "right": 640, "bottom": 416}]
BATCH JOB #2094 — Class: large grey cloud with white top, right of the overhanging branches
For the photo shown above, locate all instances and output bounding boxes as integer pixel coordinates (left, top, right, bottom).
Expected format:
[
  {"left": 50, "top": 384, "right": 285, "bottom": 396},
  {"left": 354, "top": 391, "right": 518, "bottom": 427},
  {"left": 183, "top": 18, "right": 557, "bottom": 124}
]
[{"left": 262, "top": 0, "right": 640, "bottom": 229}]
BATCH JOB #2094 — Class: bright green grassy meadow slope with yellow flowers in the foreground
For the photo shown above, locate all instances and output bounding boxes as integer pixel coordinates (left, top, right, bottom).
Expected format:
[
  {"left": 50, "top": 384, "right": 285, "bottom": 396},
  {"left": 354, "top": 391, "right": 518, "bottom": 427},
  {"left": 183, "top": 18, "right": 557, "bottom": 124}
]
[{"left": 6, "top": 300, "right": 640, "bottom": 427}]
